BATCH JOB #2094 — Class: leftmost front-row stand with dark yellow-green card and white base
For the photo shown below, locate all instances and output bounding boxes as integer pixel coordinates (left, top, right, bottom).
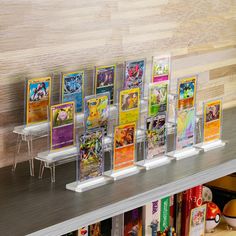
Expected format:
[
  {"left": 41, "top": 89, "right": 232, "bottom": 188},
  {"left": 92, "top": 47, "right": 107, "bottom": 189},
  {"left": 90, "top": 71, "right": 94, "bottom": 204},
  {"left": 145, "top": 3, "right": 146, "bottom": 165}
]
[{"left": 66, "top": 129, "right": 113, "bottom": 192}]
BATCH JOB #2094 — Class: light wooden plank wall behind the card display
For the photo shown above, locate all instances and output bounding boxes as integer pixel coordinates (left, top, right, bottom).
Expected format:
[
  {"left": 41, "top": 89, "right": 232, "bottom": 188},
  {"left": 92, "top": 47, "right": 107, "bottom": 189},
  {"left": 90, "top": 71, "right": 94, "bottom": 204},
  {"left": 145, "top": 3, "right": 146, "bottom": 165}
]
[{"left": 0, "top": 0, "right": 236, "bottom": 167}]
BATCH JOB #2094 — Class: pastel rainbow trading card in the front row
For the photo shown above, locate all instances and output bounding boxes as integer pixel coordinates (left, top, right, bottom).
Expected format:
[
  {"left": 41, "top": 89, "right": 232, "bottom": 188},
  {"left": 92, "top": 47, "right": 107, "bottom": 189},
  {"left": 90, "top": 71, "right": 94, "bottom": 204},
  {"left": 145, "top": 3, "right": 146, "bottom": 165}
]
[{"left": 176, "top": 107, "right": 195, "bottom": 149}]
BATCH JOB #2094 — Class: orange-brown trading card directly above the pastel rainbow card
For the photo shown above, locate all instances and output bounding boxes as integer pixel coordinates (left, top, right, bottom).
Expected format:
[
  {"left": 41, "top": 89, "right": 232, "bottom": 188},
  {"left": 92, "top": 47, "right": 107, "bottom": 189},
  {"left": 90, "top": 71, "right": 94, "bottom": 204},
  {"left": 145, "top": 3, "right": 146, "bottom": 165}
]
[{"left": 178, "top": 77, "right": 197, "bottom": 110}]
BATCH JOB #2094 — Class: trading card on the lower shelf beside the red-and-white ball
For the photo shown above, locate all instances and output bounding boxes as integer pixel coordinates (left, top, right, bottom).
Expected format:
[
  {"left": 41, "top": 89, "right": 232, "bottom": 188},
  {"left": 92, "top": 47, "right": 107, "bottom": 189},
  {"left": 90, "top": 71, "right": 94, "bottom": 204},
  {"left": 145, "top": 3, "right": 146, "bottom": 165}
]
[{"left": 189, "top": 204, "right": 206, "bottom": 236}]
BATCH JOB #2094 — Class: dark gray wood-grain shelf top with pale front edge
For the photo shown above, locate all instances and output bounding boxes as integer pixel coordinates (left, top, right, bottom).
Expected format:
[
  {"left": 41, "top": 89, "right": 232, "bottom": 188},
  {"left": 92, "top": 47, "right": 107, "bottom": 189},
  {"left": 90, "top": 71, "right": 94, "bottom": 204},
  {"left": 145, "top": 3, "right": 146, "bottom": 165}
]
[{"left": 0, "top": 108, "right": 236, "bottom": 236}]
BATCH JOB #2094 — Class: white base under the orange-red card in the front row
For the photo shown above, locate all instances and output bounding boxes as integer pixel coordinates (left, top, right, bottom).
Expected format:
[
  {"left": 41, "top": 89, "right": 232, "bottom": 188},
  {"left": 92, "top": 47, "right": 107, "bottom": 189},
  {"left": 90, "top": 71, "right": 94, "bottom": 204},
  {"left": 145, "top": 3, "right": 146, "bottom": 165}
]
[{"left": 104, "top": 166, "right": 143, "bottom": 180}]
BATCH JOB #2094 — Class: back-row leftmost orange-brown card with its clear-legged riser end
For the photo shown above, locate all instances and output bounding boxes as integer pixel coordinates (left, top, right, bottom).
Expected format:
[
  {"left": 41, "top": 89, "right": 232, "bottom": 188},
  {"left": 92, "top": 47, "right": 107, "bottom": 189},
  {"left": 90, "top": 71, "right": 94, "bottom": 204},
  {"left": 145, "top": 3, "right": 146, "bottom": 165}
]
[{"left": 12, "top": 77, "right": 52, "bottom": 176}]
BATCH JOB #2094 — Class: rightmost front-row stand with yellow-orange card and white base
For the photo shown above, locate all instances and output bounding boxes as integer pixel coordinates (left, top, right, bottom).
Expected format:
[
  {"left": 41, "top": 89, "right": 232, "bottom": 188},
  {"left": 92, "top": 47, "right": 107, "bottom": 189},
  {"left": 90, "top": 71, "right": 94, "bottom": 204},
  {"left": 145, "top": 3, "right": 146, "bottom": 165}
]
[{"left": 195, "top": 98, "right": 226, "bottom": 152}]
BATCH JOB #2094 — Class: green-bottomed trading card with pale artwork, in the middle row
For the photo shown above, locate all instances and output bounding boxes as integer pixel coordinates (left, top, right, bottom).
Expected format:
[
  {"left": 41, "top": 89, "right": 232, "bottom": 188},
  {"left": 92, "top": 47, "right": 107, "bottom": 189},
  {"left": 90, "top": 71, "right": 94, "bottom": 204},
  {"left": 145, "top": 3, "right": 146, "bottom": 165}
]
[{"left": 148, "top": 83, "right": 168, "bottom": 116}]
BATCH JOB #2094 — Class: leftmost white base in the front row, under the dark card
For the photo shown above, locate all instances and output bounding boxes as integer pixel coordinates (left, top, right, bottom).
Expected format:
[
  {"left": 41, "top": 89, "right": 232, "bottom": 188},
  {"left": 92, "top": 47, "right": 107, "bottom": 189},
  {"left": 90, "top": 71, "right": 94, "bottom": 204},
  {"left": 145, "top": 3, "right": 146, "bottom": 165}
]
[{"left": 66, "top": 176, "right": 113, "bottom": 193}]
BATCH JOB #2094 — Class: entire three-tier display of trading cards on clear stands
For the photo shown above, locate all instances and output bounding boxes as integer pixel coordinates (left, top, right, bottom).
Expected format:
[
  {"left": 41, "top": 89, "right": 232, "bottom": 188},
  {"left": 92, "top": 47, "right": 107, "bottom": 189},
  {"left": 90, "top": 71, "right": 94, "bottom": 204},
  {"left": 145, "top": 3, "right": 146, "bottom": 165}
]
[{"left": 13, "top": 61, "right": 225, "bottom": 192}]
